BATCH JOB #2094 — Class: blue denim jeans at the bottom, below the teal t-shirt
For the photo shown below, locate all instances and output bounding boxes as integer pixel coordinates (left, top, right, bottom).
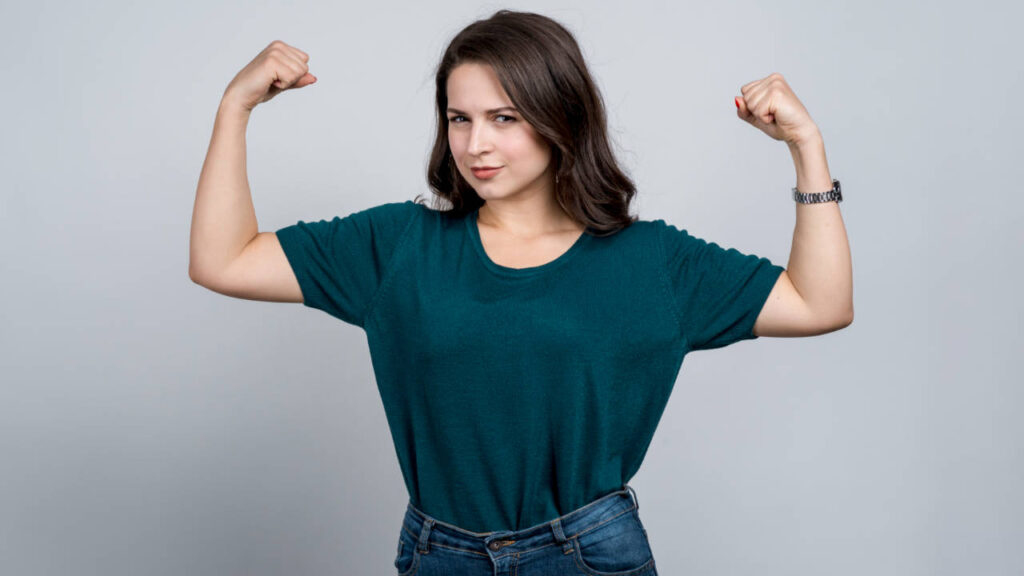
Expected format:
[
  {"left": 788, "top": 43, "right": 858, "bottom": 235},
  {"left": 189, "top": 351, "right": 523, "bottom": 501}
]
[{"left": 394, "top": 486, "right": 657, "bottom": 576}]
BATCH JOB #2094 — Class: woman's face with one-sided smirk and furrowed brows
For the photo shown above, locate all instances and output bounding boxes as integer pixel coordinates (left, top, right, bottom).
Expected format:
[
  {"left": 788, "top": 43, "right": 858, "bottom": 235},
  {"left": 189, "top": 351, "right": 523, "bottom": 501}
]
[{"left": 446, "top": 63, "right": 554, "bottom": 200}]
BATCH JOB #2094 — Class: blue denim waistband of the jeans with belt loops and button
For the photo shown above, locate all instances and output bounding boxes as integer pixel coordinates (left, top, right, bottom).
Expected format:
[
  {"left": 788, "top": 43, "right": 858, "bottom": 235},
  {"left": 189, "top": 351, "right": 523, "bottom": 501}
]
[{"left": 402, "top": 485, "right": 640, "bottom": 556}]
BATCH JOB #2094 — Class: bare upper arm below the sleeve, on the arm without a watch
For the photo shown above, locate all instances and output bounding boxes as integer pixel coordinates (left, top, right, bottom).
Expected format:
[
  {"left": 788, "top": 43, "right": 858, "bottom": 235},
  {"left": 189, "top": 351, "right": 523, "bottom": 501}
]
[{"left": 196, "top": 232, "right": 303, "bottom": 302}]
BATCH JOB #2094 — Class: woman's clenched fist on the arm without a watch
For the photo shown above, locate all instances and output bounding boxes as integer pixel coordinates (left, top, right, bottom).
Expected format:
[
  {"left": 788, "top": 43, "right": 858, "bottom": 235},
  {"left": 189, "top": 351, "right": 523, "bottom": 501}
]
[{"left": 224, "top": 40, "right": 316, "bottom": 111}]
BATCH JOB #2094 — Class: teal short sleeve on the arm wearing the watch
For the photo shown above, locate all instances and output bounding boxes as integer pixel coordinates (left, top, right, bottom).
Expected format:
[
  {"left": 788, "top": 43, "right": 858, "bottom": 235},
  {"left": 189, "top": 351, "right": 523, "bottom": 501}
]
[{"left": 655, "top": 220, "right": 785, "bottom": 351}]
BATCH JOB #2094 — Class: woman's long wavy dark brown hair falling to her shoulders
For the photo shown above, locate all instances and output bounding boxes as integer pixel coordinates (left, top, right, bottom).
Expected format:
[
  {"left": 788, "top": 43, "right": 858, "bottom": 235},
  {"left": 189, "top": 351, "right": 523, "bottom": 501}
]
[{"left": 417, "top": 10, "right": 637, "bottom": 236}]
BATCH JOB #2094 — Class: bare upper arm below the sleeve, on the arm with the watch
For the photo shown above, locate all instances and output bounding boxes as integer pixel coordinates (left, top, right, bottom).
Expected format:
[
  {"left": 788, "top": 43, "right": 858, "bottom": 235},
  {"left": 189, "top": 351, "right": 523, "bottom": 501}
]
[{"left": 754, "top": 271, "right": 850, "bottom": 336}]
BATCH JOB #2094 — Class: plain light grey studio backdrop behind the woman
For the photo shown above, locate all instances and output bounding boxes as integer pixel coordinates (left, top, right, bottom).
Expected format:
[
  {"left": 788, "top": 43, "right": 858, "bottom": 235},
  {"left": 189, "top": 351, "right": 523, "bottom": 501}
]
[{"left": 0, "top": 1, "right": 1024, "bottom": 576}]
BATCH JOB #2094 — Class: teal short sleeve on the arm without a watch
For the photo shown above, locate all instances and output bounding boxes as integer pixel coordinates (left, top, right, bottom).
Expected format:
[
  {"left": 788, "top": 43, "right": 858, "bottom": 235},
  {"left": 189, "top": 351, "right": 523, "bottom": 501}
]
[{"left": 276, "top": 200, "right": 421, "bottom": 328}]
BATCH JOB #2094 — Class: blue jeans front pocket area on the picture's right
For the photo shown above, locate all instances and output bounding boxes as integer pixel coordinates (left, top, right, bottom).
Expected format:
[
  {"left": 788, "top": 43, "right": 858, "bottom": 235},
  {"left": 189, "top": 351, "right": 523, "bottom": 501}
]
[{"left": 572, "top": 510, "right": 654, "bottom": 576}]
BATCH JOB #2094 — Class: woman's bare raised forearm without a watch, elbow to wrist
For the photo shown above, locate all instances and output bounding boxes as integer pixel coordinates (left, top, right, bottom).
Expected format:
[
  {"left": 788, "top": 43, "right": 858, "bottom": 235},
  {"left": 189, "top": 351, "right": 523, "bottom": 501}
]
[{"left": 188, "top": 97, "right": 259, "bottom": 281}]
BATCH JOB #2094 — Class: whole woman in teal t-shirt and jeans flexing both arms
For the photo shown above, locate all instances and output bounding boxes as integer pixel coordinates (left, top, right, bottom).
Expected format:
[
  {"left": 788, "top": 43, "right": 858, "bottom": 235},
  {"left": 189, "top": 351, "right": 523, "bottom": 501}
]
[{"left": 190, "top": 10, "right": 853, "bottom": 575}]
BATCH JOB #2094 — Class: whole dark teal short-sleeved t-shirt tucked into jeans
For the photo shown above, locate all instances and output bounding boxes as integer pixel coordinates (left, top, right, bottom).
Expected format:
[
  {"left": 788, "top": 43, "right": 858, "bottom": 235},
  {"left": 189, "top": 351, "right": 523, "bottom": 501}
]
[{"left": 276, "top": 201, "right": 783, "bottom": 532}]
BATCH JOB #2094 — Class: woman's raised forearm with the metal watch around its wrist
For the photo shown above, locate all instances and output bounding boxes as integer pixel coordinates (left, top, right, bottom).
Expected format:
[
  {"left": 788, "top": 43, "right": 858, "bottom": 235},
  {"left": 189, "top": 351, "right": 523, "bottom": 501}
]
[{"left": 786, "top": 130, "right": 853, "bottom": 323}]
